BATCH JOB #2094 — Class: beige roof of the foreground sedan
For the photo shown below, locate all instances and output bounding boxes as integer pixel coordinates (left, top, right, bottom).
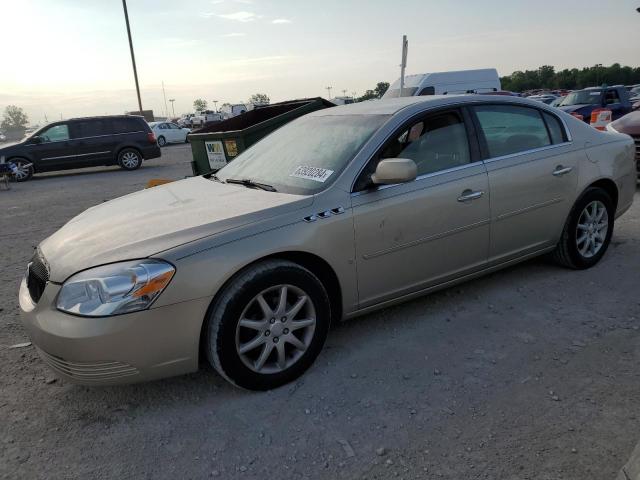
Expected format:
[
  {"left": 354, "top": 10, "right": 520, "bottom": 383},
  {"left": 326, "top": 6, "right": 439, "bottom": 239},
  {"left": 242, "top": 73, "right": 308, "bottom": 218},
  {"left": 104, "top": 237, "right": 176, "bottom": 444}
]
[{"left": 310, "top": 94, "right": 556, "bottom": 117}]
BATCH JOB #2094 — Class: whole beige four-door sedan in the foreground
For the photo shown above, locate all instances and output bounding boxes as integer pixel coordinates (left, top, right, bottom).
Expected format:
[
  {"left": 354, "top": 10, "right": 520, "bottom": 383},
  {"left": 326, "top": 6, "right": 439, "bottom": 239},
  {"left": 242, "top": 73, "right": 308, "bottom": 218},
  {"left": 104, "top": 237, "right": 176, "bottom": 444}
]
[{"left": 19, "top": 95, "right": 636, "bottom": 390}]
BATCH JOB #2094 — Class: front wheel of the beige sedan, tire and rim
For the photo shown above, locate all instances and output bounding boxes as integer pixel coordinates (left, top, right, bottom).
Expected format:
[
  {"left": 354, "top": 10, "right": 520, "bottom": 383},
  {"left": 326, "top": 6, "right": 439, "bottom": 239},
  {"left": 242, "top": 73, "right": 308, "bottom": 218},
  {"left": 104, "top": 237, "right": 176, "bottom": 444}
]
[{"left": 203, "top": 260, "right": 331, "bottom": 390}]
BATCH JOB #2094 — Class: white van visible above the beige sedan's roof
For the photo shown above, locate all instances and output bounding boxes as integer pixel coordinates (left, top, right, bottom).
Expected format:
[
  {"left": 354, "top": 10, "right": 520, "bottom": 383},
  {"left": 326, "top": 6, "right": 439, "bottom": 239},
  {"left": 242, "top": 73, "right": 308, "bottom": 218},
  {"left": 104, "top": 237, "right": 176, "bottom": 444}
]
[{"left": 382, "top": 68, "right": 500, "bottom": 98}]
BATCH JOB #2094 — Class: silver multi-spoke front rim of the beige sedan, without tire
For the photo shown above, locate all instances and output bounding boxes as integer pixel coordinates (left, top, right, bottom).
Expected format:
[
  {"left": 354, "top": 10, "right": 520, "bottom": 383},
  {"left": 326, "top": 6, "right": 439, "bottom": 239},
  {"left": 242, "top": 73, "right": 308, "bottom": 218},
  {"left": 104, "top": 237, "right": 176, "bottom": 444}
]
[{"left": 236, "top": 285, "right": 316, "bottom": 374}]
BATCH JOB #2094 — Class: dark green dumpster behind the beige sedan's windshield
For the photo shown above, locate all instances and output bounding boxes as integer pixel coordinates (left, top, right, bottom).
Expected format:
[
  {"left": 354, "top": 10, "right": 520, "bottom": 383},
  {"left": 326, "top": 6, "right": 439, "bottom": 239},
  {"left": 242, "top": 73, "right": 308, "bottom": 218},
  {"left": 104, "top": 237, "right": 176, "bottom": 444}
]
[{"left": 189, "top": 97, "right": 334, "bottom": 175}]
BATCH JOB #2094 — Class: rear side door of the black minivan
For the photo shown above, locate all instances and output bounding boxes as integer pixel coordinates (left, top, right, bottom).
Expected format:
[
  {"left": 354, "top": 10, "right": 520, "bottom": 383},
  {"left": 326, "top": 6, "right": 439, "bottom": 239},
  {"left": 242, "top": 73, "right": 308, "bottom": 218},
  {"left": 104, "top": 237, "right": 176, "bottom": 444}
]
[{"left": 71, "top": 118, "right": 114, "bottom": 167}]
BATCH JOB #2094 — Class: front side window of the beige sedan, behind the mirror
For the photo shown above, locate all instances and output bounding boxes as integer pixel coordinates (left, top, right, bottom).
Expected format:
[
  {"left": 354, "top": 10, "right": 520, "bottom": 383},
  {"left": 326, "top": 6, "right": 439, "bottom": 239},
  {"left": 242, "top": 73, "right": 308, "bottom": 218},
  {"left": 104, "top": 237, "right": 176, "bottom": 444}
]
[{"left": 355, "top": 110, "right": 471, "bottom": 191}]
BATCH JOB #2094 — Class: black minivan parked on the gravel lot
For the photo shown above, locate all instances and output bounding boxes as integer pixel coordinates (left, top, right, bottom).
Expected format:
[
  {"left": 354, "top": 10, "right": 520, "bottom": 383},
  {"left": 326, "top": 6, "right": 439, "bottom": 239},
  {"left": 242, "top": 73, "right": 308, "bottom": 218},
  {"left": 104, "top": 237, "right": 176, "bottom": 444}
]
[{"left": 0, "top": 115, "right": 160, "bottom": 182}]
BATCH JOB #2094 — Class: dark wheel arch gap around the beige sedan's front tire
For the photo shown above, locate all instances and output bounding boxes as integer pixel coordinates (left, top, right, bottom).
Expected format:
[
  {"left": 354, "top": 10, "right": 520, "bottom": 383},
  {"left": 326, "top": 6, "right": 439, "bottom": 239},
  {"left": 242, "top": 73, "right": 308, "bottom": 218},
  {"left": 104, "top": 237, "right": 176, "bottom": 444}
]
[{"left": 199, "top": 250, "right": 343, "bottom": 358}]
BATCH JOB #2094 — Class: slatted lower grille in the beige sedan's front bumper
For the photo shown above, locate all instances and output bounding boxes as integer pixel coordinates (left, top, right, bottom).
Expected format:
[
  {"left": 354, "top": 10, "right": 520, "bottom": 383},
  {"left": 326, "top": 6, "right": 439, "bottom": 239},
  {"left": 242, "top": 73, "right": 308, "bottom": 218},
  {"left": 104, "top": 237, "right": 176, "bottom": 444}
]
[{"left": 38, "top": 349, "right": 139, "bottom": 383}]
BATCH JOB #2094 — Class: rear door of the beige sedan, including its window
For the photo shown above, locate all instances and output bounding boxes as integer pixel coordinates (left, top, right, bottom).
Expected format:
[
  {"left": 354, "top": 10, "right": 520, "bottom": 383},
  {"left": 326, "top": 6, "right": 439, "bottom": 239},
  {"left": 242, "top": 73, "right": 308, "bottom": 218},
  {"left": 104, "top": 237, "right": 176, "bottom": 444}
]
[{"left": 472, "top": 104, "right": 584, "bottom": 263}]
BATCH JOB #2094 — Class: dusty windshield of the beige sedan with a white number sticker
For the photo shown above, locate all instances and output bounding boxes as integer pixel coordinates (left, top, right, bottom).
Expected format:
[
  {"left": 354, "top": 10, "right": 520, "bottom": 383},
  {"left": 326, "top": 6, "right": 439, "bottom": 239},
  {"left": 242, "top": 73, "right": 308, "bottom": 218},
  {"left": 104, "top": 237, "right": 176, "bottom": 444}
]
[{"left": 216, "top": 115, "right": 388, "bottom": 195}]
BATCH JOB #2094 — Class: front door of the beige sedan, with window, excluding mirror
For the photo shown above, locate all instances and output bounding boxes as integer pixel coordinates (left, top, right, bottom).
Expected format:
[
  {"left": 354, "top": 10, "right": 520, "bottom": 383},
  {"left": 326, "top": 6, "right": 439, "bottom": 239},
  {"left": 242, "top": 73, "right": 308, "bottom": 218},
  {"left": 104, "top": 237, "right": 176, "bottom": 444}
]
[{"left": 352, "top": 110, "right": 490, "bottom": 307}]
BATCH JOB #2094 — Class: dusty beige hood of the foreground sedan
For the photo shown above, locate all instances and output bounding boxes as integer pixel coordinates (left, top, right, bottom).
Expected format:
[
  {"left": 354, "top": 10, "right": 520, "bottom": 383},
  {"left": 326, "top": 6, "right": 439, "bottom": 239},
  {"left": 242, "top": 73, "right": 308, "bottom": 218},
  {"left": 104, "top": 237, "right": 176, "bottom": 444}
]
[{"left": 39, "top": 177, "right": 313, "bottom": 282}]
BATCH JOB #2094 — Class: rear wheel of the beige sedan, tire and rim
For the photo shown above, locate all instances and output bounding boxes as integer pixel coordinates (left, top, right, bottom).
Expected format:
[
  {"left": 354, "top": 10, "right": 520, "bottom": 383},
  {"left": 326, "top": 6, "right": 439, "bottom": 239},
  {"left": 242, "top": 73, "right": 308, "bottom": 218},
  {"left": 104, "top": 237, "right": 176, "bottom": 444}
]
[{"left": 553, "top": 187, "right": 615, "bottom": 270}]
